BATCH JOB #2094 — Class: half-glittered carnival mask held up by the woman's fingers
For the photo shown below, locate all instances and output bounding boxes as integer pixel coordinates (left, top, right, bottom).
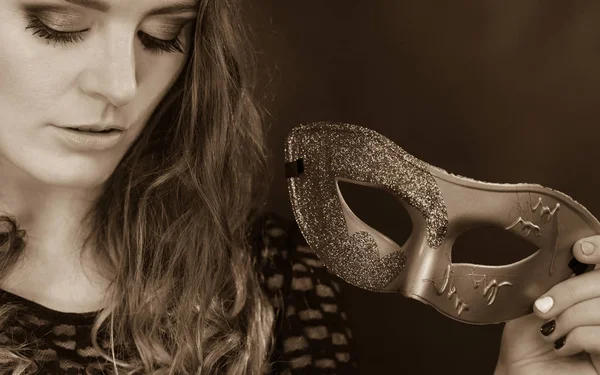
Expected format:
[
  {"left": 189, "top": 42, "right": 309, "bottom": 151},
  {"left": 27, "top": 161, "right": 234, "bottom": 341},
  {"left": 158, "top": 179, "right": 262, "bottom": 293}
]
[{"left": 285, "top": 123, "right": 600, "bottom": 324}]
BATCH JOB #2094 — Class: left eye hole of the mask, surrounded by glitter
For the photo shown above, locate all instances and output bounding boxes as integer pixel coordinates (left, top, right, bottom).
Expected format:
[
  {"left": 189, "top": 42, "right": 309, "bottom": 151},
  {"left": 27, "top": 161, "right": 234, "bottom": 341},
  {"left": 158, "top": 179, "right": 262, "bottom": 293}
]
[{"left": 337, "top": 179, "right": 413, "bottom": 246}]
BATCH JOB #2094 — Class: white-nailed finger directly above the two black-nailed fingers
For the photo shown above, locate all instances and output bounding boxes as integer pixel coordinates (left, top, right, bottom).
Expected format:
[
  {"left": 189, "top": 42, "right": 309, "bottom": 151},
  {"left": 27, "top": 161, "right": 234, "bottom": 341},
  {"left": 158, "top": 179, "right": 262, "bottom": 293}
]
[{"left": 533, "top": 270, "right": 600, "bottom": 320}]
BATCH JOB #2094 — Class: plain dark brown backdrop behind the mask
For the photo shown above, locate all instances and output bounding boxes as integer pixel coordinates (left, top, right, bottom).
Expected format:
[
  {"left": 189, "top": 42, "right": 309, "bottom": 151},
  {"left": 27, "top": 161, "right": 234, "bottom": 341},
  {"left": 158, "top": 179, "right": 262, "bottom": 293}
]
[{"left": 247, "top": 0, "right": 600, "bottom": 375}]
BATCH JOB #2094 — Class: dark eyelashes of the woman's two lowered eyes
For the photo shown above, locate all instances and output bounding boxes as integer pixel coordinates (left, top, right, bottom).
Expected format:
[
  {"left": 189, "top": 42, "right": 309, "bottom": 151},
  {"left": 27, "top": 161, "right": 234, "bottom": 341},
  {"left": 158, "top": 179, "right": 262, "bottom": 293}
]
[{"left": 25, "top": 15, "right": 184, "bottom": 54}]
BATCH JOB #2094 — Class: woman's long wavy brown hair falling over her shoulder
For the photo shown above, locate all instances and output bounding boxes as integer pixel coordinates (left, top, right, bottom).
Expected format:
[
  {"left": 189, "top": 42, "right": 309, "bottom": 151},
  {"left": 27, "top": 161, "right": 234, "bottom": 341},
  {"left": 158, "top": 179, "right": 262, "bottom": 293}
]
[{"left": 0, "top": 0, "right": 274, "bottom": 375}]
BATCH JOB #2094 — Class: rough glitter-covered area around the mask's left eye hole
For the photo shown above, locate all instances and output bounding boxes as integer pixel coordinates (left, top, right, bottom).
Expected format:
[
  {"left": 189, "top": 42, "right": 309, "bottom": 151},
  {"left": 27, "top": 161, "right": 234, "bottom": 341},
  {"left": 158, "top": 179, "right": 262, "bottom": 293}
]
[{"left": 285, "top": 122, "right": 448, "bottom": 290}]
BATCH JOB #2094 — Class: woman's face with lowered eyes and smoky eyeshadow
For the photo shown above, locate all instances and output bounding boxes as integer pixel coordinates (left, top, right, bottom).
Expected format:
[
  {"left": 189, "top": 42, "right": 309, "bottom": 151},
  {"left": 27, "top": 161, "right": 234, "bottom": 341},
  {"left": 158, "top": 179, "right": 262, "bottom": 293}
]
[{"left": 0, "top": 0, "right": 198, "bottom": 188}]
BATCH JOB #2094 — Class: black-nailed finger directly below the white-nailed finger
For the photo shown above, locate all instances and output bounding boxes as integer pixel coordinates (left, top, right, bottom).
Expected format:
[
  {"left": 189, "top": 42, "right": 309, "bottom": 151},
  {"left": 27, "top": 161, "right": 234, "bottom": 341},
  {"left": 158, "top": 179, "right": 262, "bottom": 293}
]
[{"left": 540, "top": 298, "right": 600, "bottom": 342}]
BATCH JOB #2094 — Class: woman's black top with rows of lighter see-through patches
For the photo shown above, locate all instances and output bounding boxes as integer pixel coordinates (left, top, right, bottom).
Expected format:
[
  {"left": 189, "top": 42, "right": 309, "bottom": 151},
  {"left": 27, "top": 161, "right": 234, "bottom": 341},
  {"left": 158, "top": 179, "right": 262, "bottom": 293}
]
[{"left": 0, "top": 213, "right": 358, "bottom": 375}]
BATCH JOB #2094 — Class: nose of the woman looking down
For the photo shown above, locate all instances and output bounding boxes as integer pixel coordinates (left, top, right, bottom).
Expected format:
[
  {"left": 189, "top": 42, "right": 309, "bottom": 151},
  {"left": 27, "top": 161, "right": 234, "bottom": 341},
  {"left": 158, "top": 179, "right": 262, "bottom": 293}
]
[{"left": 80, "top": 31, "right": 137, "bottom": 107}]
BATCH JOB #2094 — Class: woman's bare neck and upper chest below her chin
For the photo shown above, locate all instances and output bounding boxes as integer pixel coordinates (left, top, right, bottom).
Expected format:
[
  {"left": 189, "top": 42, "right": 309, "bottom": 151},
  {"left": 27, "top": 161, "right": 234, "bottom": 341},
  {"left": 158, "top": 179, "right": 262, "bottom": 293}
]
[{"left": 0, "top": 160, "right": 115, "bottom": 312}]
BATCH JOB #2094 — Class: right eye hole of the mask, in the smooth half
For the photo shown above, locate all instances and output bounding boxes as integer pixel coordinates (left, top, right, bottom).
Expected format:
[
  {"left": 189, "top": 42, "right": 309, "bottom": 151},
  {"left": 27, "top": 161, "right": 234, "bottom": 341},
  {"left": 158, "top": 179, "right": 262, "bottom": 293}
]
[{"left": 452, "top": 226, "right": 538, "bottom": 266}]
